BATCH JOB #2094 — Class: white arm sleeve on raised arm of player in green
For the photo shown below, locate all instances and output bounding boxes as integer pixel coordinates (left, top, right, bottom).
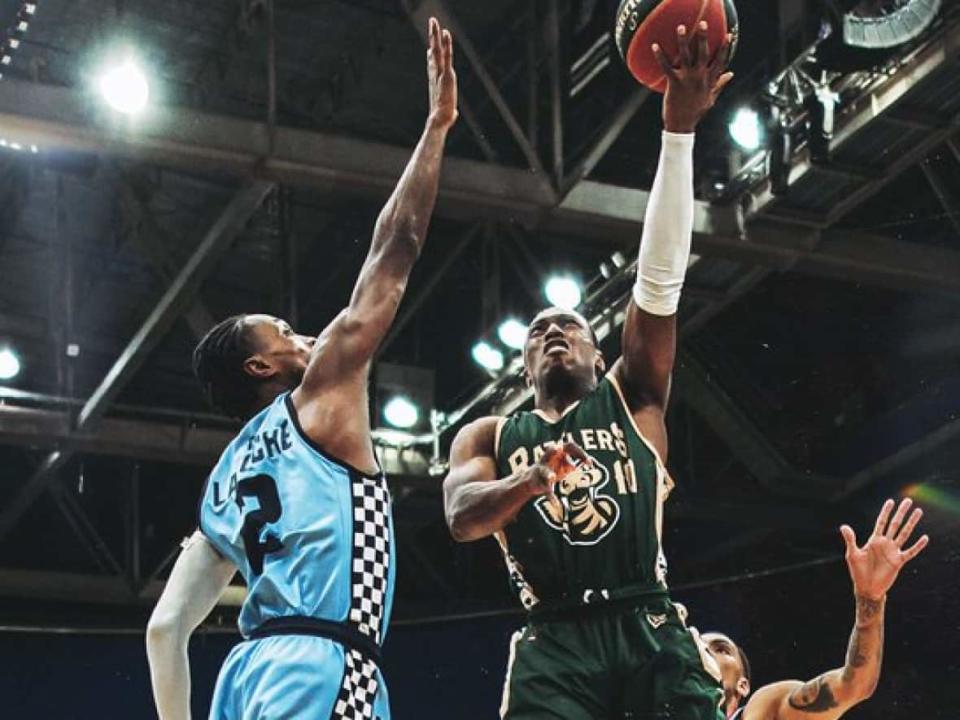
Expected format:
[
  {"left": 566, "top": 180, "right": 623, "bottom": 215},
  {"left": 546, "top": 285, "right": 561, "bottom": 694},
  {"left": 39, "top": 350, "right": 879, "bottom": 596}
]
[{"left": 633, "top": 132, "right": 694, "bottom": 316}]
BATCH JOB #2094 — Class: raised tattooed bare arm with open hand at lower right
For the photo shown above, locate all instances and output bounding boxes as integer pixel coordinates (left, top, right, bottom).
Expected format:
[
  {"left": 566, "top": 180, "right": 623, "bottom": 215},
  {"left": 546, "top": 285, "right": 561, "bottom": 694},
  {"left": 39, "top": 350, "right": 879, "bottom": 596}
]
[{"left": 743, "top": 499, "right": 929, "bottom": 720}]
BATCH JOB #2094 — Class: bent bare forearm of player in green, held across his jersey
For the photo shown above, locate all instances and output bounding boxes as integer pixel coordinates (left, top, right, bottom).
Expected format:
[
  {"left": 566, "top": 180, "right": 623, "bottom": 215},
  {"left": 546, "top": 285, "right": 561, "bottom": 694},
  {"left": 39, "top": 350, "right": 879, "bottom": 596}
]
[{"left": 446, "top": 473, "right": 533, "bottom": 542}]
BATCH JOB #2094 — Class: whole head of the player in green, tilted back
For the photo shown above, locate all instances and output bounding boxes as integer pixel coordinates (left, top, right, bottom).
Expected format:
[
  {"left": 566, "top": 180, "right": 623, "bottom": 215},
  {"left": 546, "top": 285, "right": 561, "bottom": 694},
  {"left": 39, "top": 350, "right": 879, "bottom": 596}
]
[{"left": 523, "top": 307, "right": 605, "bottom": 392}]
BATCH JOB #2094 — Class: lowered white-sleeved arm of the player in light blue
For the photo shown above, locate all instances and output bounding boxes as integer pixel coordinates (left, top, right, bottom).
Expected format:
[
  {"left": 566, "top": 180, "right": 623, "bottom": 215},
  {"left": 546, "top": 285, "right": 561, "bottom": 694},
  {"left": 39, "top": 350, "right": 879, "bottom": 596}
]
[{"left": 147, "top": 531, "right": 237, "bottom": 720}]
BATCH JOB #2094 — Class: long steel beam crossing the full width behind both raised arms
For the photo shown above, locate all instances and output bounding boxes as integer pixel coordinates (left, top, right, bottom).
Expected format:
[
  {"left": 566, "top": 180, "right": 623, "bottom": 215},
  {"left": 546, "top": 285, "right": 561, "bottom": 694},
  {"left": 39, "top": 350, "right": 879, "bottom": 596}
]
[{"left": 0, "top": 81, "right": 960, "bottom": 292}]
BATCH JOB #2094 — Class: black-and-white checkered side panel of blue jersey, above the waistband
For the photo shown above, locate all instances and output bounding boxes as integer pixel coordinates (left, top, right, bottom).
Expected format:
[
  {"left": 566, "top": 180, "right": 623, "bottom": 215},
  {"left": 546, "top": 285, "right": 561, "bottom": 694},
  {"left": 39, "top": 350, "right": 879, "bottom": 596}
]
[{"left": 349, "top": 474, "right": 391, "bottom": 644}]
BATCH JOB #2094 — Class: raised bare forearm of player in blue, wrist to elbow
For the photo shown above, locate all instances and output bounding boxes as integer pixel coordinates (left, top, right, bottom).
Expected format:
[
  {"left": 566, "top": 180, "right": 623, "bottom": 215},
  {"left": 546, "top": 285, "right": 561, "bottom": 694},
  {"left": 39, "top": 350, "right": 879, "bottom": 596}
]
[{"left": 372, "top": 120, "right": 449, "bottom": 260}]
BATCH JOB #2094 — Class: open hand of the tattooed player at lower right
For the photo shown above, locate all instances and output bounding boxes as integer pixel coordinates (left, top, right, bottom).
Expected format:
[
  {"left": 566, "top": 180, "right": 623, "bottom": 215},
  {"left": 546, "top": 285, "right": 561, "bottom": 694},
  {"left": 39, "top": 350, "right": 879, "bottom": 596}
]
[{"left": 840, "top": 498, "right": 930, "bottom": 600}]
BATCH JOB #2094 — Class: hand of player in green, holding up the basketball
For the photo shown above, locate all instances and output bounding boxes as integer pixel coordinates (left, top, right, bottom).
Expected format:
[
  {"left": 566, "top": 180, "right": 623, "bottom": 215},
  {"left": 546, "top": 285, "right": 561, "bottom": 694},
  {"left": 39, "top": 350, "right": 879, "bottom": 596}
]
[{"left": 653, "top": 21, "right": 733, "bottom": 133}]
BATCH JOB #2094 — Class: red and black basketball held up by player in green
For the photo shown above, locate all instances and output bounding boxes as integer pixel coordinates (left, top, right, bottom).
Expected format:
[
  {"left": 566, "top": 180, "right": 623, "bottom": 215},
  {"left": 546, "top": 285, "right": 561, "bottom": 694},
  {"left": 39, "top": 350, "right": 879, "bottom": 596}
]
[{"left": 614, "top": 0, "right": 739, "bottom": 93}]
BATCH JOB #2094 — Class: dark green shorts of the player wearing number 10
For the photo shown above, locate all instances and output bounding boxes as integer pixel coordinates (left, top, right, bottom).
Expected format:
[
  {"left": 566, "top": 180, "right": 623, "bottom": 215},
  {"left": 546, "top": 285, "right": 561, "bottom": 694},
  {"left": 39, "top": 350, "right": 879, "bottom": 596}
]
[{"left": 500, "top": 598, "right": 723, "bottom": 720}]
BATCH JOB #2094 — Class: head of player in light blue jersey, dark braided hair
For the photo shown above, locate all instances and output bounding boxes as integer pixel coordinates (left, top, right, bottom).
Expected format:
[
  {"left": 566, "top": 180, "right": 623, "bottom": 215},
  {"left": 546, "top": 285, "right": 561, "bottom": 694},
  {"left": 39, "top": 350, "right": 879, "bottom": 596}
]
[{"left": 193, "top": 315, "right": 315, "bottom": 419}]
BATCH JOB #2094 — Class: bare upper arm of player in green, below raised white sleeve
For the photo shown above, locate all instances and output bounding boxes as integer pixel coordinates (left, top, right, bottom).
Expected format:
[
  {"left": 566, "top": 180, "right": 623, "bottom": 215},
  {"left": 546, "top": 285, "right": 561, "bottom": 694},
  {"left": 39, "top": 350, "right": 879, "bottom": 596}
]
[{"left": 619, "top": 298, "right": 677, "bottom": 408}]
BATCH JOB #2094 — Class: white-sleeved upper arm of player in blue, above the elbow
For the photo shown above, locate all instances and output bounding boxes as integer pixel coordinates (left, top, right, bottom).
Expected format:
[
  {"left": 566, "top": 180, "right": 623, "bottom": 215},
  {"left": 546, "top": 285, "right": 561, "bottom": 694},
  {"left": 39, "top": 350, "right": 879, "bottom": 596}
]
[{"left": 151, "top": 530, "right": 237, "bottom": 633}]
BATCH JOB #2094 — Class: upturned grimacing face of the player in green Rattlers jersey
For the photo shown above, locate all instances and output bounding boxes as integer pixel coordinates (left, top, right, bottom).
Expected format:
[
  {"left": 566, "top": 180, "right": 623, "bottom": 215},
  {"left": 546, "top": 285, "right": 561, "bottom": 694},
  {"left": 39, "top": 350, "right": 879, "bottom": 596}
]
[{"left": 524, "top": 308, "right": 598, "bottom": 388}]
